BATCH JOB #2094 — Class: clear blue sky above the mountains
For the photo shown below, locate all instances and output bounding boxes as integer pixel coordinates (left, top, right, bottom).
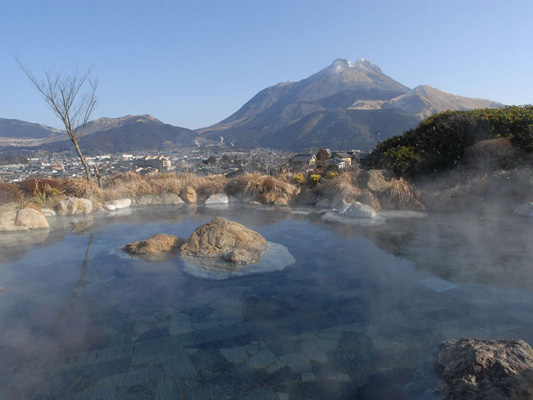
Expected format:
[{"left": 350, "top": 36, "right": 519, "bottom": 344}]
[{"left": 0, "top": 0, "right": 533, "bottom": 128}]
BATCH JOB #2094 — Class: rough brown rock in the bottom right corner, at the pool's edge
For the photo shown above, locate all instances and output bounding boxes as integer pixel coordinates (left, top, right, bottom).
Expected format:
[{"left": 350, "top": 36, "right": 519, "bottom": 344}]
[{"left": 430, "top": 339, "right": 533, "bottom": 400}]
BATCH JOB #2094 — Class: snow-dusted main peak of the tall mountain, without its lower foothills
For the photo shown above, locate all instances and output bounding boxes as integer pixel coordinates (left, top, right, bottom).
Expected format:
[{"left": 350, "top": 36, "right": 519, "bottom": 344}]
[{"left": 199, "top": 58, "right": 409, "bottom": 133}]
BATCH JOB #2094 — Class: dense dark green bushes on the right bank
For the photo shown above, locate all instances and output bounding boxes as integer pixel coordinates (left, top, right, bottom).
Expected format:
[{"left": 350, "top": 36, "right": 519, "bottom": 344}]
[{"left": 364, "top": 105, "right": 533, "bottom": 177}]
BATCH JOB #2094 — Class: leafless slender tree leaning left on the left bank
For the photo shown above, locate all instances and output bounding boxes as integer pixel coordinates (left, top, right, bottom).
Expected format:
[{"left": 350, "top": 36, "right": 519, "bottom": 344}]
[{"left": 15, "top": 56, "right": 98, "bottom": 181}]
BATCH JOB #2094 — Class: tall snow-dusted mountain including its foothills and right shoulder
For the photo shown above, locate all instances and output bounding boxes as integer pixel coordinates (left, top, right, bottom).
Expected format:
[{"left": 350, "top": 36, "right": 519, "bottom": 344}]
[{"left": 198, "top": 58, "right": 502, "bottom": 151}]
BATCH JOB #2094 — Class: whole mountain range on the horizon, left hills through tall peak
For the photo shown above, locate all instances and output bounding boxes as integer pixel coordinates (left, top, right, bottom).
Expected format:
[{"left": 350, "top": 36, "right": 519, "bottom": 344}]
[{"left": 0, "top": 58, "right": 503, "bottom": 153}]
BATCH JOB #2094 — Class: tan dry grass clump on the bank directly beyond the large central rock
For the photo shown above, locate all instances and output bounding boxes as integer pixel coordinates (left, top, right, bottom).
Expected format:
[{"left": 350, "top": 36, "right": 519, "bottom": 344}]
[{"left": 226, "top": 173, "right": 300, "bottom": 201}]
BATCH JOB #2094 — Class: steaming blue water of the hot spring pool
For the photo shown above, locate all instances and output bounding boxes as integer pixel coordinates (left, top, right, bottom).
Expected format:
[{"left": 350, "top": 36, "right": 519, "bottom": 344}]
[{"left": 0, "top": 206, "right": 533, "bottom": 399}]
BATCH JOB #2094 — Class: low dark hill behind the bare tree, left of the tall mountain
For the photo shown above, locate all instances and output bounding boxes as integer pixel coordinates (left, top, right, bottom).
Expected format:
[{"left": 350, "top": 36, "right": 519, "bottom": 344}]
[{"left": 43, "top": 115, "right": 197, "bottom": 154}]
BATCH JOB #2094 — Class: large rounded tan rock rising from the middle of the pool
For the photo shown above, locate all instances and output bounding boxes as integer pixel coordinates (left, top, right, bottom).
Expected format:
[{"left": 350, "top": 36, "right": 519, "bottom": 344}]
[{"left": 180, "top": 217, "right": 268, "bottom": 264}]
